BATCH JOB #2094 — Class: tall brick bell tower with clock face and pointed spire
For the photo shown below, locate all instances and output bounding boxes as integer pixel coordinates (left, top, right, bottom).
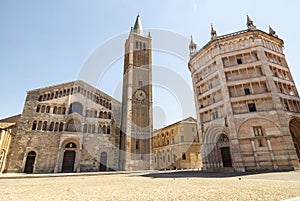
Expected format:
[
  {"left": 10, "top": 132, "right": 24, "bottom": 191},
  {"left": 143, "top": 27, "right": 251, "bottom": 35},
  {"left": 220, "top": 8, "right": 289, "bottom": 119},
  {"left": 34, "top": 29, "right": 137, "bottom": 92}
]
[{"left": 120, "top": 15, "right": 153, "bottom": 170}]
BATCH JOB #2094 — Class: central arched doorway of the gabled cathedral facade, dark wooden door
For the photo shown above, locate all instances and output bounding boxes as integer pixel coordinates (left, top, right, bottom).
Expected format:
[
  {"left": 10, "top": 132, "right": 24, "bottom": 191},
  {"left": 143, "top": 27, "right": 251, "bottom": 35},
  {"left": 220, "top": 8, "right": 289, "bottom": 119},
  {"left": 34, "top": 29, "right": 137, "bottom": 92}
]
[{"left": 62, "top": 142, "right": 77, "bottom": 172}]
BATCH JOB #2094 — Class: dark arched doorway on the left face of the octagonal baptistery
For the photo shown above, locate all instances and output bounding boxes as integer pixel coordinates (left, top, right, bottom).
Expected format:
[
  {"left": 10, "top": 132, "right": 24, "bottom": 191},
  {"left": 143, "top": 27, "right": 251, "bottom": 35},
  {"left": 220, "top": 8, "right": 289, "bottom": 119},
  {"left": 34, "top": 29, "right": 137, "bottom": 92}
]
[{"left": 217, "top": 134, "right": 232, "bottom": 167}]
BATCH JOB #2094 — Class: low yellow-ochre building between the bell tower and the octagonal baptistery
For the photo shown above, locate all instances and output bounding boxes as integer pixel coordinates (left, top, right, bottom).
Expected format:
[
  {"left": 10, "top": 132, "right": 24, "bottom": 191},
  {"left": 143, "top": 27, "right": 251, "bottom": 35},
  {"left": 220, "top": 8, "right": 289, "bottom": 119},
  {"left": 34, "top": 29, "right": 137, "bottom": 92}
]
[{"left": 152, "top": 117, "right": 202, "bottom": 170}]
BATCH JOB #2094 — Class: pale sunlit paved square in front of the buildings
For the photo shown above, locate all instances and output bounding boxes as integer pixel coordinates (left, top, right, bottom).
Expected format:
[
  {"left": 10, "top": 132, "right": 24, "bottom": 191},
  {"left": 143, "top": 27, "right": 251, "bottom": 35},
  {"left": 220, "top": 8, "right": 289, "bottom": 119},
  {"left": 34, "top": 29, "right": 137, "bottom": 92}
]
[{"left": 0, "top": 171, "right": 300, "bottom": 201}]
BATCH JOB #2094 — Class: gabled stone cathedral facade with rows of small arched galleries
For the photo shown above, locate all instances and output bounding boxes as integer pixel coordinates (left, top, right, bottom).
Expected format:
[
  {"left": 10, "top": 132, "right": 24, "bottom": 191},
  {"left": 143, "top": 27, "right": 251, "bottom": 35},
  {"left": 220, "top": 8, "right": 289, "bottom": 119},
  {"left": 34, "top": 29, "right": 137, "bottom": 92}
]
[{"left": 6, "top": 81, "right": 121, "bottom": 173}]
